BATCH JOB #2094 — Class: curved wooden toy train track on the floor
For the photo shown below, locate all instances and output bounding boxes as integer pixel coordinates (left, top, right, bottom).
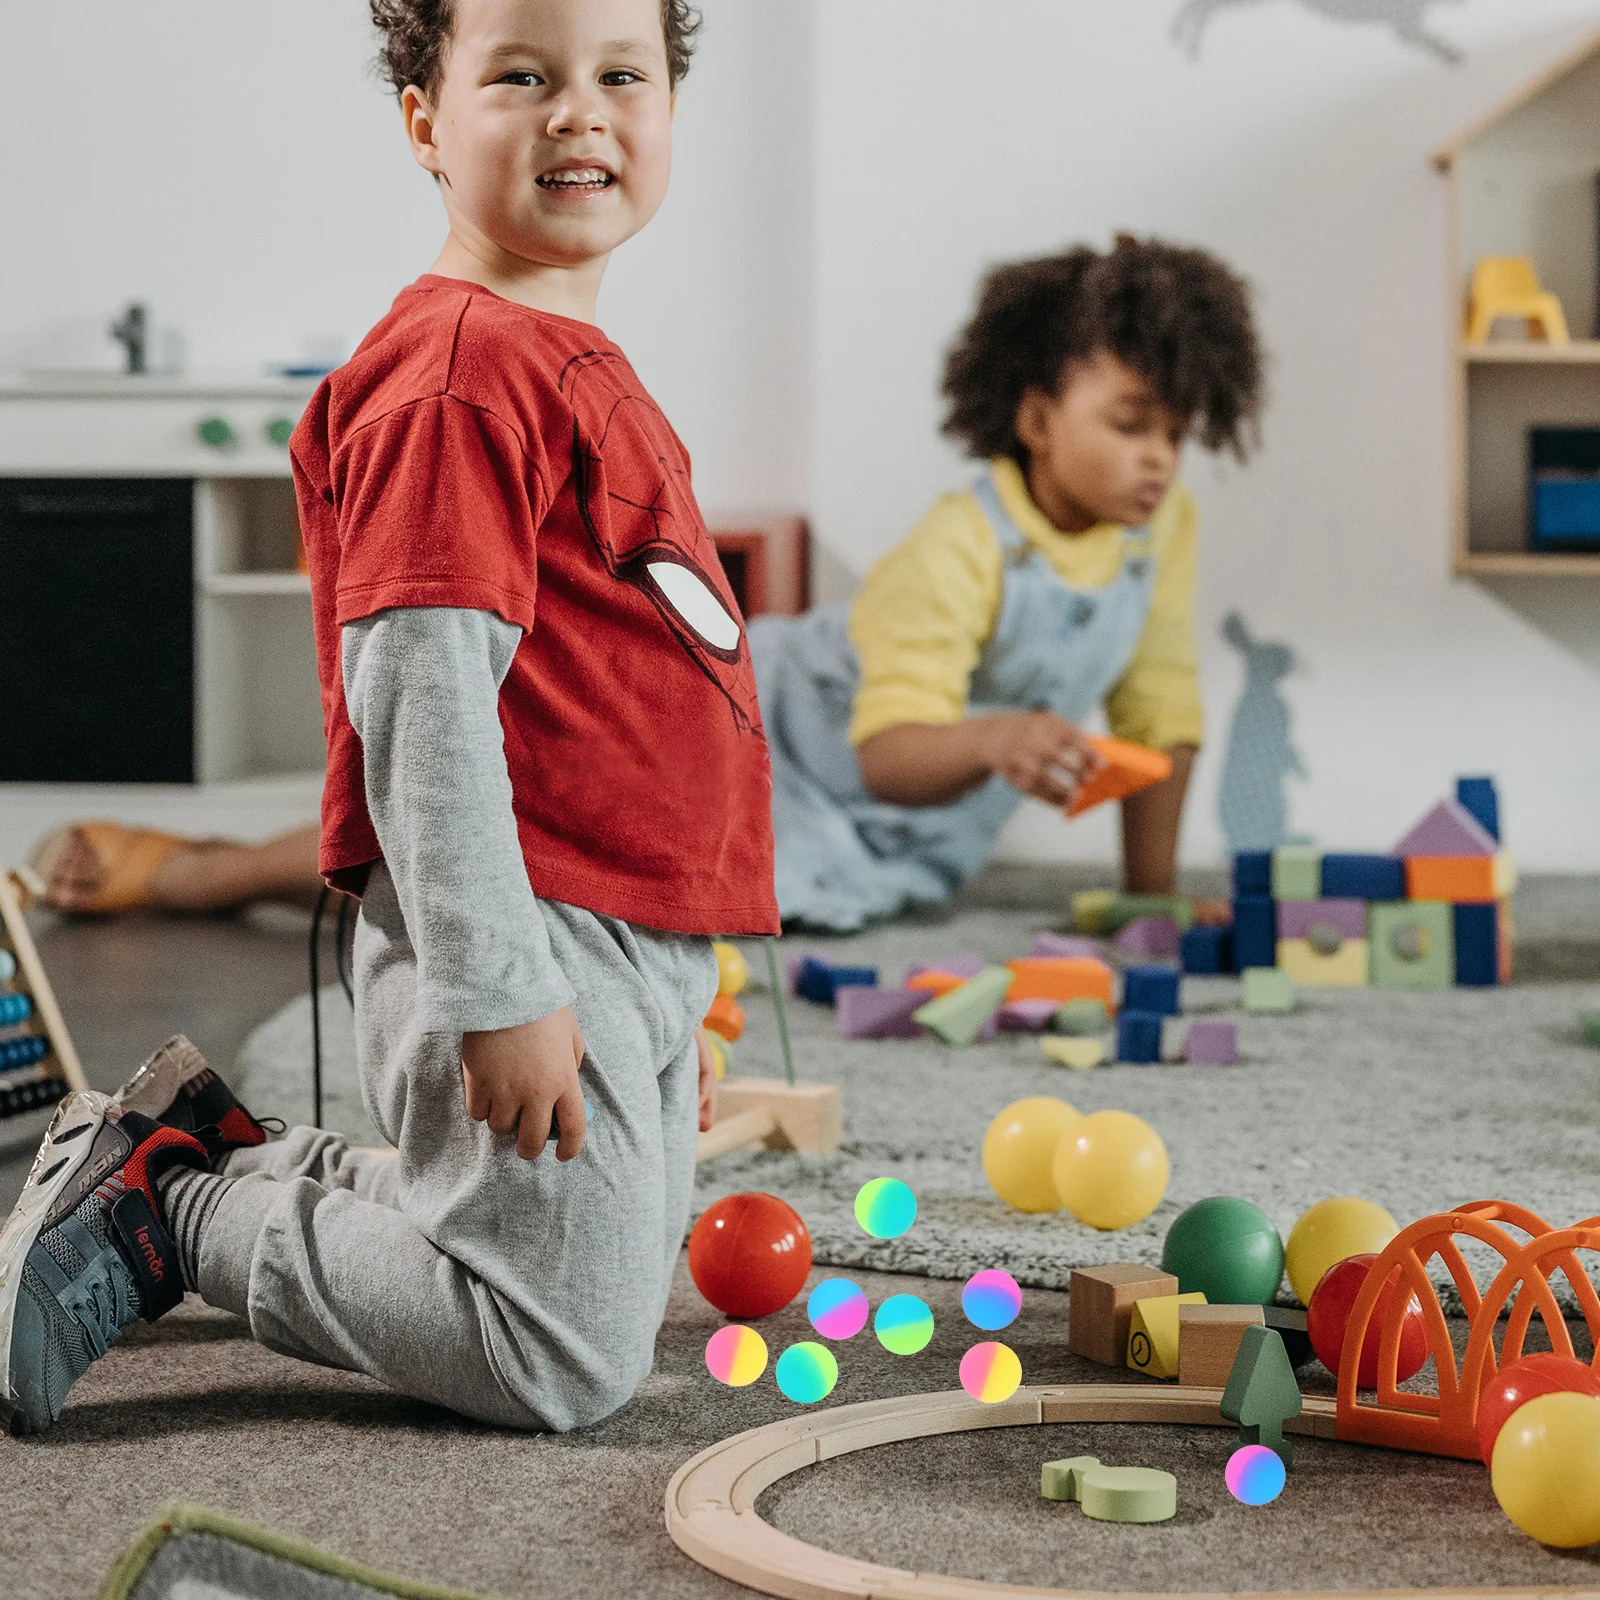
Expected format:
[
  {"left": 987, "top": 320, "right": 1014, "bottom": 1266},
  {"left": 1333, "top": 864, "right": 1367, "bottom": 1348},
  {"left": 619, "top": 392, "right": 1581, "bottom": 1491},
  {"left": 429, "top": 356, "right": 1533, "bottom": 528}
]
[{"left": 666, "top": 1384, "right": 1600, "bottom": 1600}]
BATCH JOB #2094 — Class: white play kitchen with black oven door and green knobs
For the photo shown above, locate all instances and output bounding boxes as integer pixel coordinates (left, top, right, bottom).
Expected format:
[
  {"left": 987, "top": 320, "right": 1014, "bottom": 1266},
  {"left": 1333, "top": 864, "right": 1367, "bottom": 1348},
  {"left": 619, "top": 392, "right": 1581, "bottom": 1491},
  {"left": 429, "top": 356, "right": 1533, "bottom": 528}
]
[{"left": 0, "top": 306, "right": 323, "bottom": 784}]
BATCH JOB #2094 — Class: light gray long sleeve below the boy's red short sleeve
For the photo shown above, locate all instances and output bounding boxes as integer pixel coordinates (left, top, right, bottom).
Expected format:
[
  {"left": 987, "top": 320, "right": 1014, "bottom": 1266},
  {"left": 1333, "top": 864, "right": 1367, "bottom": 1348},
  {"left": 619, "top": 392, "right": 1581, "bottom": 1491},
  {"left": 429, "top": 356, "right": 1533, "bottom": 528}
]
[{"left": 339, "top": 606, "right": 573, "bottom": 1034}]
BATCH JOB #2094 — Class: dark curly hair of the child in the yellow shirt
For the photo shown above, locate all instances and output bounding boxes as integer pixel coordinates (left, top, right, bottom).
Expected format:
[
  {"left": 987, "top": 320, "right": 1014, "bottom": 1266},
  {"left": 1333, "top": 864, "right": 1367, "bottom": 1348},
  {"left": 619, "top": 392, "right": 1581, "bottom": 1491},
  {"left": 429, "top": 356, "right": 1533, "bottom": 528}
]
[{"left": 944, "top": 234, "right": 1262, "bottom": 466}]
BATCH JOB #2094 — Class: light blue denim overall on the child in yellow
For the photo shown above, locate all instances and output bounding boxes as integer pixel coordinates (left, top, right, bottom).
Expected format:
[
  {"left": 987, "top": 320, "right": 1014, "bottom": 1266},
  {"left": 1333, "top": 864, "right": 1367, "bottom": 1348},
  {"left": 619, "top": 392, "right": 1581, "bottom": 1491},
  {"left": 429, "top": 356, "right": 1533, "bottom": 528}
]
[{"left": 749, "top": 474, "right": 1155, "bottom": 931}]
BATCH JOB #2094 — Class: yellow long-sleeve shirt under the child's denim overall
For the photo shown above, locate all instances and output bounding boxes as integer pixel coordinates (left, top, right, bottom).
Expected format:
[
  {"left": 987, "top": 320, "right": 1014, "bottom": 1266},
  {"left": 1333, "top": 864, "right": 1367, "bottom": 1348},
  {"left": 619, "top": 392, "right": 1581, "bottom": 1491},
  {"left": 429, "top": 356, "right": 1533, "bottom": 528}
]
[{"left": 850, "top": 461, "right": 1205, "bottom": 749}]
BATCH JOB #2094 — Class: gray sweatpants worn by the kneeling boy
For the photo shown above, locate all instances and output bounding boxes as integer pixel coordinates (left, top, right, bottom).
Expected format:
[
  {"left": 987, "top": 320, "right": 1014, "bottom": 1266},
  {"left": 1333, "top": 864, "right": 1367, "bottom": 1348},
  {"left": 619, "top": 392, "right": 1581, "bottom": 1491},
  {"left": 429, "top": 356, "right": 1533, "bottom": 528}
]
[{"left": 198, "top": 864, "right": 717, "bottom": 1430}]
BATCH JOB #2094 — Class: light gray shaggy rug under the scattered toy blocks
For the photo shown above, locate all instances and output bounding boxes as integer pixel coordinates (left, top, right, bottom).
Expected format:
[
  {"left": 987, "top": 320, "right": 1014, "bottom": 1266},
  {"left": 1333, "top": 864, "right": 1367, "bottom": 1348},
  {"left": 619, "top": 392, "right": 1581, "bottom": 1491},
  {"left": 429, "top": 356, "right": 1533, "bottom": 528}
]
[{"left": 237, "top": 888, "right": 1600, "bottom": 1288}]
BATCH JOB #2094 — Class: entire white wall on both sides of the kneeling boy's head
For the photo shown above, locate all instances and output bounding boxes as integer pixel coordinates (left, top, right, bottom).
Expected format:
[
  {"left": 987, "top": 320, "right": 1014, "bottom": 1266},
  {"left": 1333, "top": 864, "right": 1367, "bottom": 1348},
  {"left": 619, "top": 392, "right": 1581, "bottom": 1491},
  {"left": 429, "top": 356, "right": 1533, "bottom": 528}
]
[{"left": 0, "top": 0, "right": 1600, "bottom": 867}]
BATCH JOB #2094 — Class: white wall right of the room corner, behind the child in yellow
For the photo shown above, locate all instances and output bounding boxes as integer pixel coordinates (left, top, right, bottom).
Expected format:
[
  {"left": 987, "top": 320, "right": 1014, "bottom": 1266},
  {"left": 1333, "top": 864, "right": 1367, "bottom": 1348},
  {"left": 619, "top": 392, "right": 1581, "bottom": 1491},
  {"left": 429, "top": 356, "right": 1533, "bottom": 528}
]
[{"left": 813, "top": 0, "right": 1600, "bottom": 867}]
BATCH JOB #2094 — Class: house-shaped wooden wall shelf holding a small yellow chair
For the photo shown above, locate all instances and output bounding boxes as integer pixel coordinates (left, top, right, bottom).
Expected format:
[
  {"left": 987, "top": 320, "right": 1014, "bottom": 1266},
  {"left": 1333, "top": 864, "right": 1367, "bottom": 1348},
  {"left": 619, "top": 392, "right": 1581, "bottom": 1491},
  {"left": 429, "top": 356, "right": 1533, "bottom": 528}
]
[{"left": 1434, "top": 34, "right": 1600, "bottom": 578}]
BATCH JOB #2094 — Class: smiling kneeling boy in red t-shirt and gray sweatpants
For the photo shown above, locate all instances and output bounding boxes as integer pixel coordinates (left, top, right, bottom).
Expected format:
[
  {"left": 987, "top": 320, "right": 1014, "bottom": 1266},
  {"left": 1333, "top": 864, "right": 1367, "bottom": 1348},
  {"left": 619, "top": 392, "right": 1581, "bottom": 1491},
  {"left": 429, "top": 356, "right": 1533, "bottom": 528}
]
[{"left": 0, "top": 0, "right": 778, "bottom": 1432}]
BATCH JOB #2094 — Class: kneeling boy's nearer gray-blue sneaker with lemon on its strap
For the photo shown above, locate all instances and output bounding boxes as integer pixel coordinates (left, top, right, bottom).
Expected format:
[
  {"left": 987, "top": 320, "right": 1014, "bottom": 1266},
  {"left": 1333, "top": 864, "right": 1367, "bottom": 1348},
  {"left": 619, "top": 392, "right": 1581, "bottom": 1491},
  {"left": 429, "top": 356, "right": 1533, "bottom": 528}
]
[{"left": 0, "top": 1093, "right": 210, "bottom": 1435}]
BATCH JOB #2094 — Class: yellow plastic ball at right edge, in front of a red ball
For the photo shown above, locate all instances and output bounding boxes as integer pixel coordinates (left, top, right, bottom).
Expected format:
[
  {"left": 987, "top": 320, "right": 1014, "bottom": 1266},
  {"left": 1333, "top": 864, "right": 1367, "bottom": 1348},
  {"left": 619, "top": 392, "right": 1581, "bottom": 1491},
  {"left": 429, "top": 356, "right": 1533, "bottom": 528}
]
[{"left": 1490, "top": 1394, "right": 1600, "bottom": 1550}]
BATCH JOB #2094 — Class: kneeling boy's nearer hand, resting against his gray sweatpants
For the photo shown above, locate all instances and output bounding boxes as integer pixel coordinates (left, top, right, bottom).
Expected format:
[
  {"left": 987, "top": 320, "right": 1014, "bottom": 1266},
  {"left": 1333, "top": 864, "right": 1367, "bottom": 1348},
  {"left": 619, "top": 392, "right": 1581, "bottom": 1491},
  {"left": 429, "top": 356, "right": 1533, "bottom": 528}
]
[{"left": 461, "top": 1006, "right": 587, "bottom": 1162}]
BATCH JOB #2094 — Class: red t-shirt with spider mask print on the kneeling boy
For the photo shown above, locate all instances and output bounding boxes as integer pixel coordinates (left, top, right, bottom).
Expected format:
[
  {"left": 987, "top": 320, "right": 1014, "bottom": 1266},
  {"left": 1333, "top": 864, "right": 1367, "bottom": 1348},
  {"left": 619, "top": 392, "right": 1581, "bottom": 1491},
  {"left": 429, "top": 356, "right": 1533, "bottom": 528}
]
[{"left": 290, "top": 277, "right": 778, "bottom": 934}]
